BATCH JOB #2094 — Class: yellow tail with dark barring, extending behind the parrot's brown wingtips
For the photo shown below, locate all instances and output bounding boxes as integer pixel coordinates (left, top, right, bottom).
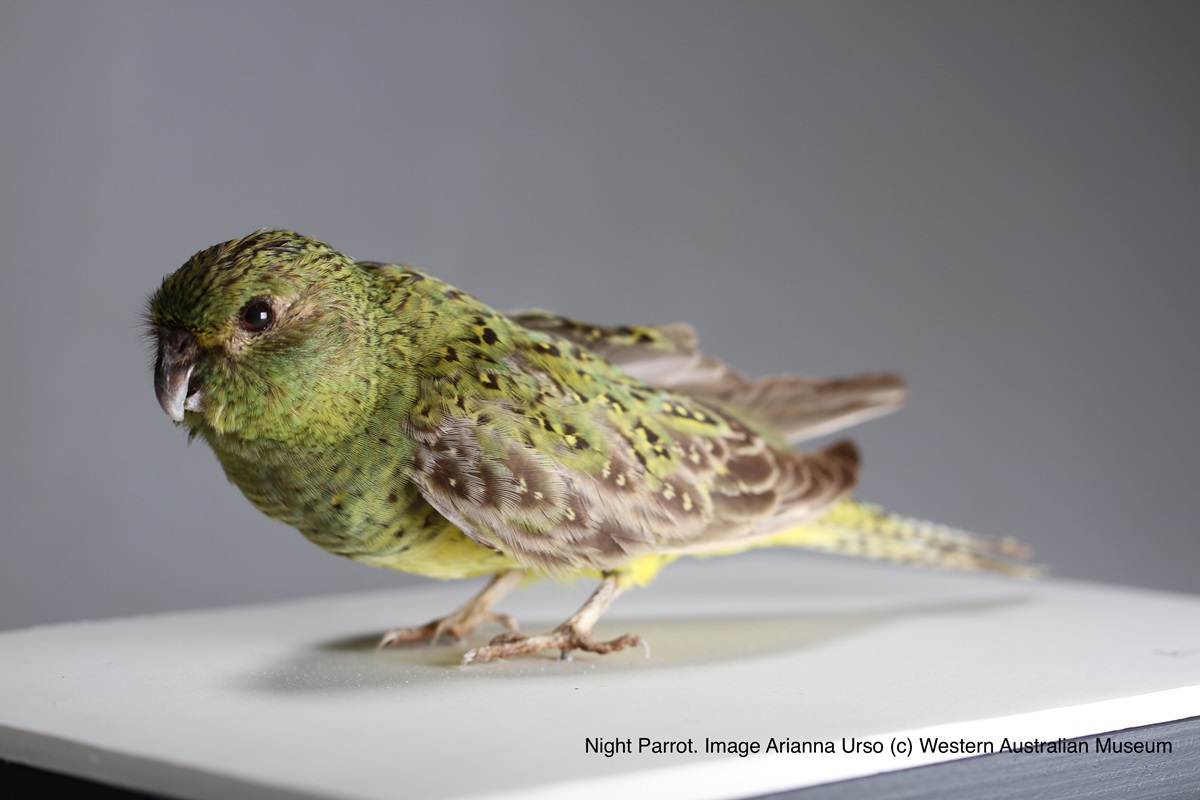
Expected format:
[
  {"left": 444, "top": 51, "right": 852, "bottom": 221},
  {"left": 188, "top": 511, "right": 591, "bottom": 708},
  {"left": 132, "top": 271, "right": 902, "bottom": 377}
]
[{"left": 720, "top": 499, "right": 1043, "bottom": 578}]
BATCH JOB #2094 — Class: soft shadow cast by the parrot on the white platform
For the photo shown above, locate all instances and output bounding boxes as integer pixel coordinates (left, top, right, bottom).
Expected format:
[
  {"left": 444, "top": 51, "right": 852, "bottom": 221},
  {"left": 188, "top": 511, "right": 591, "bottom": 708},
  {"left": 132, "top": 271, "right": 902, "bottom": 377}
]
[{"left": 234, "top": 596, "right": 1027, "bottom": 693}]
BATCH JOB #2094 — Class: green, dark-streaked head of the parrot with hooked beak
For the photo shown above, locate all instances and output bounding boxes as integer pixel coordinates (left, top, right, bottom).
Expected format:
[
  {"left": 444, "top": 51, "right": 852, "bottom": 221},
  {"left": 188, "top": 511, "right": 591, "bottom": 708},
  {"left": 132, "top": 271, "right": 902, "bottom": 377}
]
[{"left": 146, "top": 230, "right": 376, "bottom": 444}]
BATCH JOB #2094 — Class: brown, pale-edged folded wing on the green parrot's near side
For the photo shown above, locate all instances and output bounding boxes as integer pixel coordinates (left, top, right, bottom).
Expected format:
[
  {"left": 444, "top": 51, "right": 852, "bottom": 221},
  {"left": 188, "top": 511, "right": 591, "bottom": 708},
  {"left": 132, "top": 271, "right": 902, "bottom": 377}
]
[{"left": 410, "top": 383, "right": 858, "bottom": 573}]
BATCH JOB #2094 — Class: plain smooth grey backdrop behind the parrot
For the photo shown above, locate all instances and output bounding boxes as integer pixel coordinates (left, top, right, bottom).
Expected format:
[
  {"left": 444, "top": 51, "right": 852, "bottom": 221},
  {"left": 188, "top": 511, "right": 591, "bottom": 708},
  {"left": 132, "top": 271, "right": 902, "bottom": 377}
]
[{"left": 0, "top": 0, "right": 1200, "bottom": 627}]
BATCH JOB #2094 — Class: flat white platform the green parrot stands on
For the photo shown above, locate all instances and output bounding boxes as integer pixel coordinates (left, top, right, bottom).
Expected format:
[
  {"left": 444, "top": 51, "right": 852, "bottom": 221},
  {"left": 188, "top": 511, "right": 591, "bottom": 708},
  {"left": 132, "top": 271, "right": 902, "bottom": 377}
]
[{"left": 0, "top": 552, "right": 1200, "bottom": 799}]
